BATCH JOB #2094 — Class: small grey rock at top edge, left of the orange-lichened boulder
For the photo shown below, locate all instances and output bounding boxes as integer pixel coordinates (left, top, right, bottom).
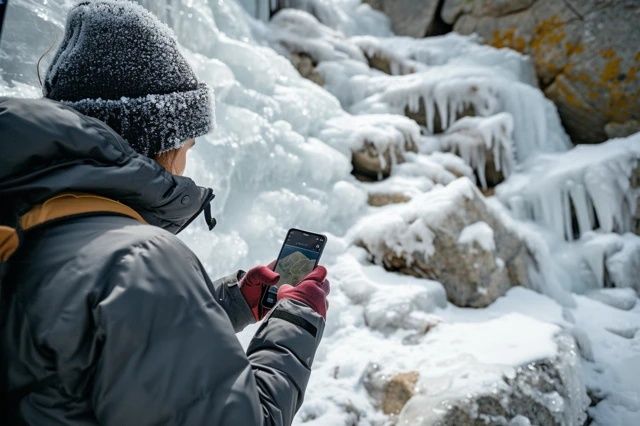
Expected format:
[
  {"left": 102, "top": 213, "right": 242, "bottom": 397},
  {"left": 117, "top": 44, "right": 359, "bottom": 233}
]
[{"left": 364, "top": 0, "right": 442, "bottom": 37}]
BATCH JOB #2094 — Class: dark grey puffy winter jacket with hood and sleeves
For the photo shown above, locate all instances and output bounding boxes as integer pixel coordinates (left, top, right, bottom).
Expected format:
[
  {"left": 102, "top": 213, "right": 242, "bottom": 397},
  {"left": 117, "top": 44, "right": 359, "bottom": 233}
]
[{"left": 0, "top": 98, "right": 324, "bottom": 426}]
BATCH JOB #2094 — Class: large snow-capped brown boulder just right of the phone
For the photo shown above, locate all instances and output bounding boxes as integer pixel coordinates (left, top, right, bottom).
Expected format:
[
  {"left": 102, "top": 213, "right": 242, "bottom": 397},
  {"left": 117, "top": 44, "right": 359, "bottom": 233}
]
[{"left": 352, "top": 178, "right": 529, "bottom": 307}]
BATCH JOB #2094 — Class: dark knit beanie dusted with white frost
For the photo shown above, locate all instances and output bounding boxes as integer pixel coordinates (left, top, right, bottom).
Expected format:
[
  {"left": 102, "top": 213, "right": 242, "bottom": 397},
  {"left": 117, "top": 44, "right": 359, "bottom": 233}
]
[{"left": 43, "top": 0, "right": 214, "bottom": 157}]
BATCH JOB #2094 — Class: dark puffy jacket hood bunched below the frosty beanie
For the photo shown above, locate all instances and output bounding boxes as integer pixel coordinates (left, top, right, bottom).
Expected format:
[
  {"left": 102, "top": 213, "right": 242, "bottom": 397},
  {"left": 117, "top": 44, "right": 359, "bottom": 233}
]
[{"left": 0, "top": 97, "right": 213, "bottom": 233}]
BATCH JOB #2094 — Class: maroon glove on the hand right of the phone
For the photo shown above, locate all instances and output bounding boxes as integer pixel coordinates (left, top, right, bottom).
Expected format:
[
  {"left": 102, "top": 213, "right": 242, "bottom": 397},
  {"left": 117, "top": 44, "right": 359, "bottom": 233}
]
[{"left": 278, "top": 266, "right": 330, "bottom": 319}]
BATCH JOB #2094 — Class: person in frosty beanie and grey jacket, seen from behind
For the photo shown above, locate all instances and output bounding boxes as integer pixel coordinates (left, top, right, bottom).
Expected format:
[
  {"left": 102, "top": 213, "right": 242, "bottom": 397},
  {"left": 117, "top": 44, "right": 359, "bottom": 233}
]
[{"left": 0, "top": 0, "right": 329, "bottom": 426}]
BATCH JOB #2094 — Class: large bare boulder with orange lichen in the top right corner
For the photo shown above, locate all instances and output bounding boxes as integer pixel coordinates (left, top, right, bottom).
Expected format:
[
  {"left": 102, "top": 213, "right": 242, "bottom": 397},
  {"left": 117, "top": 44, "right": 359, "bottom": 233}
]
[{"left": 442, "top": 0, "right": 640, "bottom": 143}]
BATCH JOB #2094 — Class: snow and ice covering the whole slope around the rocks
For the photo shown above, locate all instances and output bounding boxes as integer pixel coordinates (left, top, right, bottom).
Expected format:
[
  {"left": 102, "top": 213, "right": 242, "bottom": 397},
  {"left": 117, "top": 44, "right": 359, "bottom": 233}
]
[{"left": 0, "top": 0, "right": 640, "bottom": 425}]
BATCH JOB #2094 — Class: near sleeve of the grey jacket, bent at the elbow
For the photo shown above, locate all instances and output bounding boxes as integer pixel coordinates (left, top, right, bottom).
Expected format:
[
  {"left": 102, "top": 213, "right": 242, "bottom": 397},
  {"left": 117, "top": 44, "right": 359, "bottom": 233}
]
[{"left": 92, "top": 235, "right": 324, "bottom": 425}]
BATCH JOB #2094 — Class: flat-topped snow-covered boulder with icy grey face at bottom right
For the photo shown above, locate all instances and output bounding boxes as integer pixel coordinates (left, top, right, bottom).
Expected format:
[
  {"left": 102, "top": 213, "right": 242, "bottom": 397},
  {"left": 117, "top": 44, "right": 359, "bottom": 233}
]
[{"left": 363, "top": 314, "right": 588, "bottom": 426}]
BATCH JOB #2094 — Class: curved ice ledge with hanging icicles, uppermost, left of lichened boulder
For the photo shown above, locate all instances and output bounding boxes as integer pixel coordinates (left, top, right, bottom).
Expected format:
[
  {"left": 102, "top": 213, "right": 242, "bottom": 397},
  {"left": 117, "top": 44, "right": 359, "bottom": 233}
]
[{"left": 350, "top": 64, "right": 569, "bottom": 162}]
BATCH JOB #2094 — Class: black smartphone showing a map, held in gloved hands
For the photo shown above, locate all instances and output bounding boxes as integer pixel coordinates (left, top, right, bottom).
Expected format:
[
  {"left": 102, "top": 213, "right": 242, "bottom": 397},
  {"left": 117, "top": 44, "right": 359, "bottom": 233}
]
[{"left": 262, "top": 228, "right": 327, "bottom": 309}]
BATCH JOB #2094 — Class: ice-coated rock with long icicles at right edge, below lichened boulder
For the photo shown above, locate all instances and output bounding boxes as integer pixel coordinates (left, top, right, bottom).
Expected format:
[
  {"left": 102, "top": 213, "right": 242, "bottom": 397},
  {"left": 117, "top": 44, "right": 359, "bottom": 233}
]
[{"left": 496, "top": 133, "right": 640, "bottom": 240}]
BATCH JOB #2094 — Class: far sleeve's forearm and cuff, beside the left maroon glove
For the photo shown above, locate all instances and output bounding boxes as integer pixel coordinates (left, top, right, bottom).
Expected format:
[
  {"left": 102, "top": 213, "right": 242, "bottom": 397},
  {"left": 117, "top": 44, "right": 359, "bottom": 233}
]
[{"left": 205, "top": 271, "right": 256, "bottom": 333}]
